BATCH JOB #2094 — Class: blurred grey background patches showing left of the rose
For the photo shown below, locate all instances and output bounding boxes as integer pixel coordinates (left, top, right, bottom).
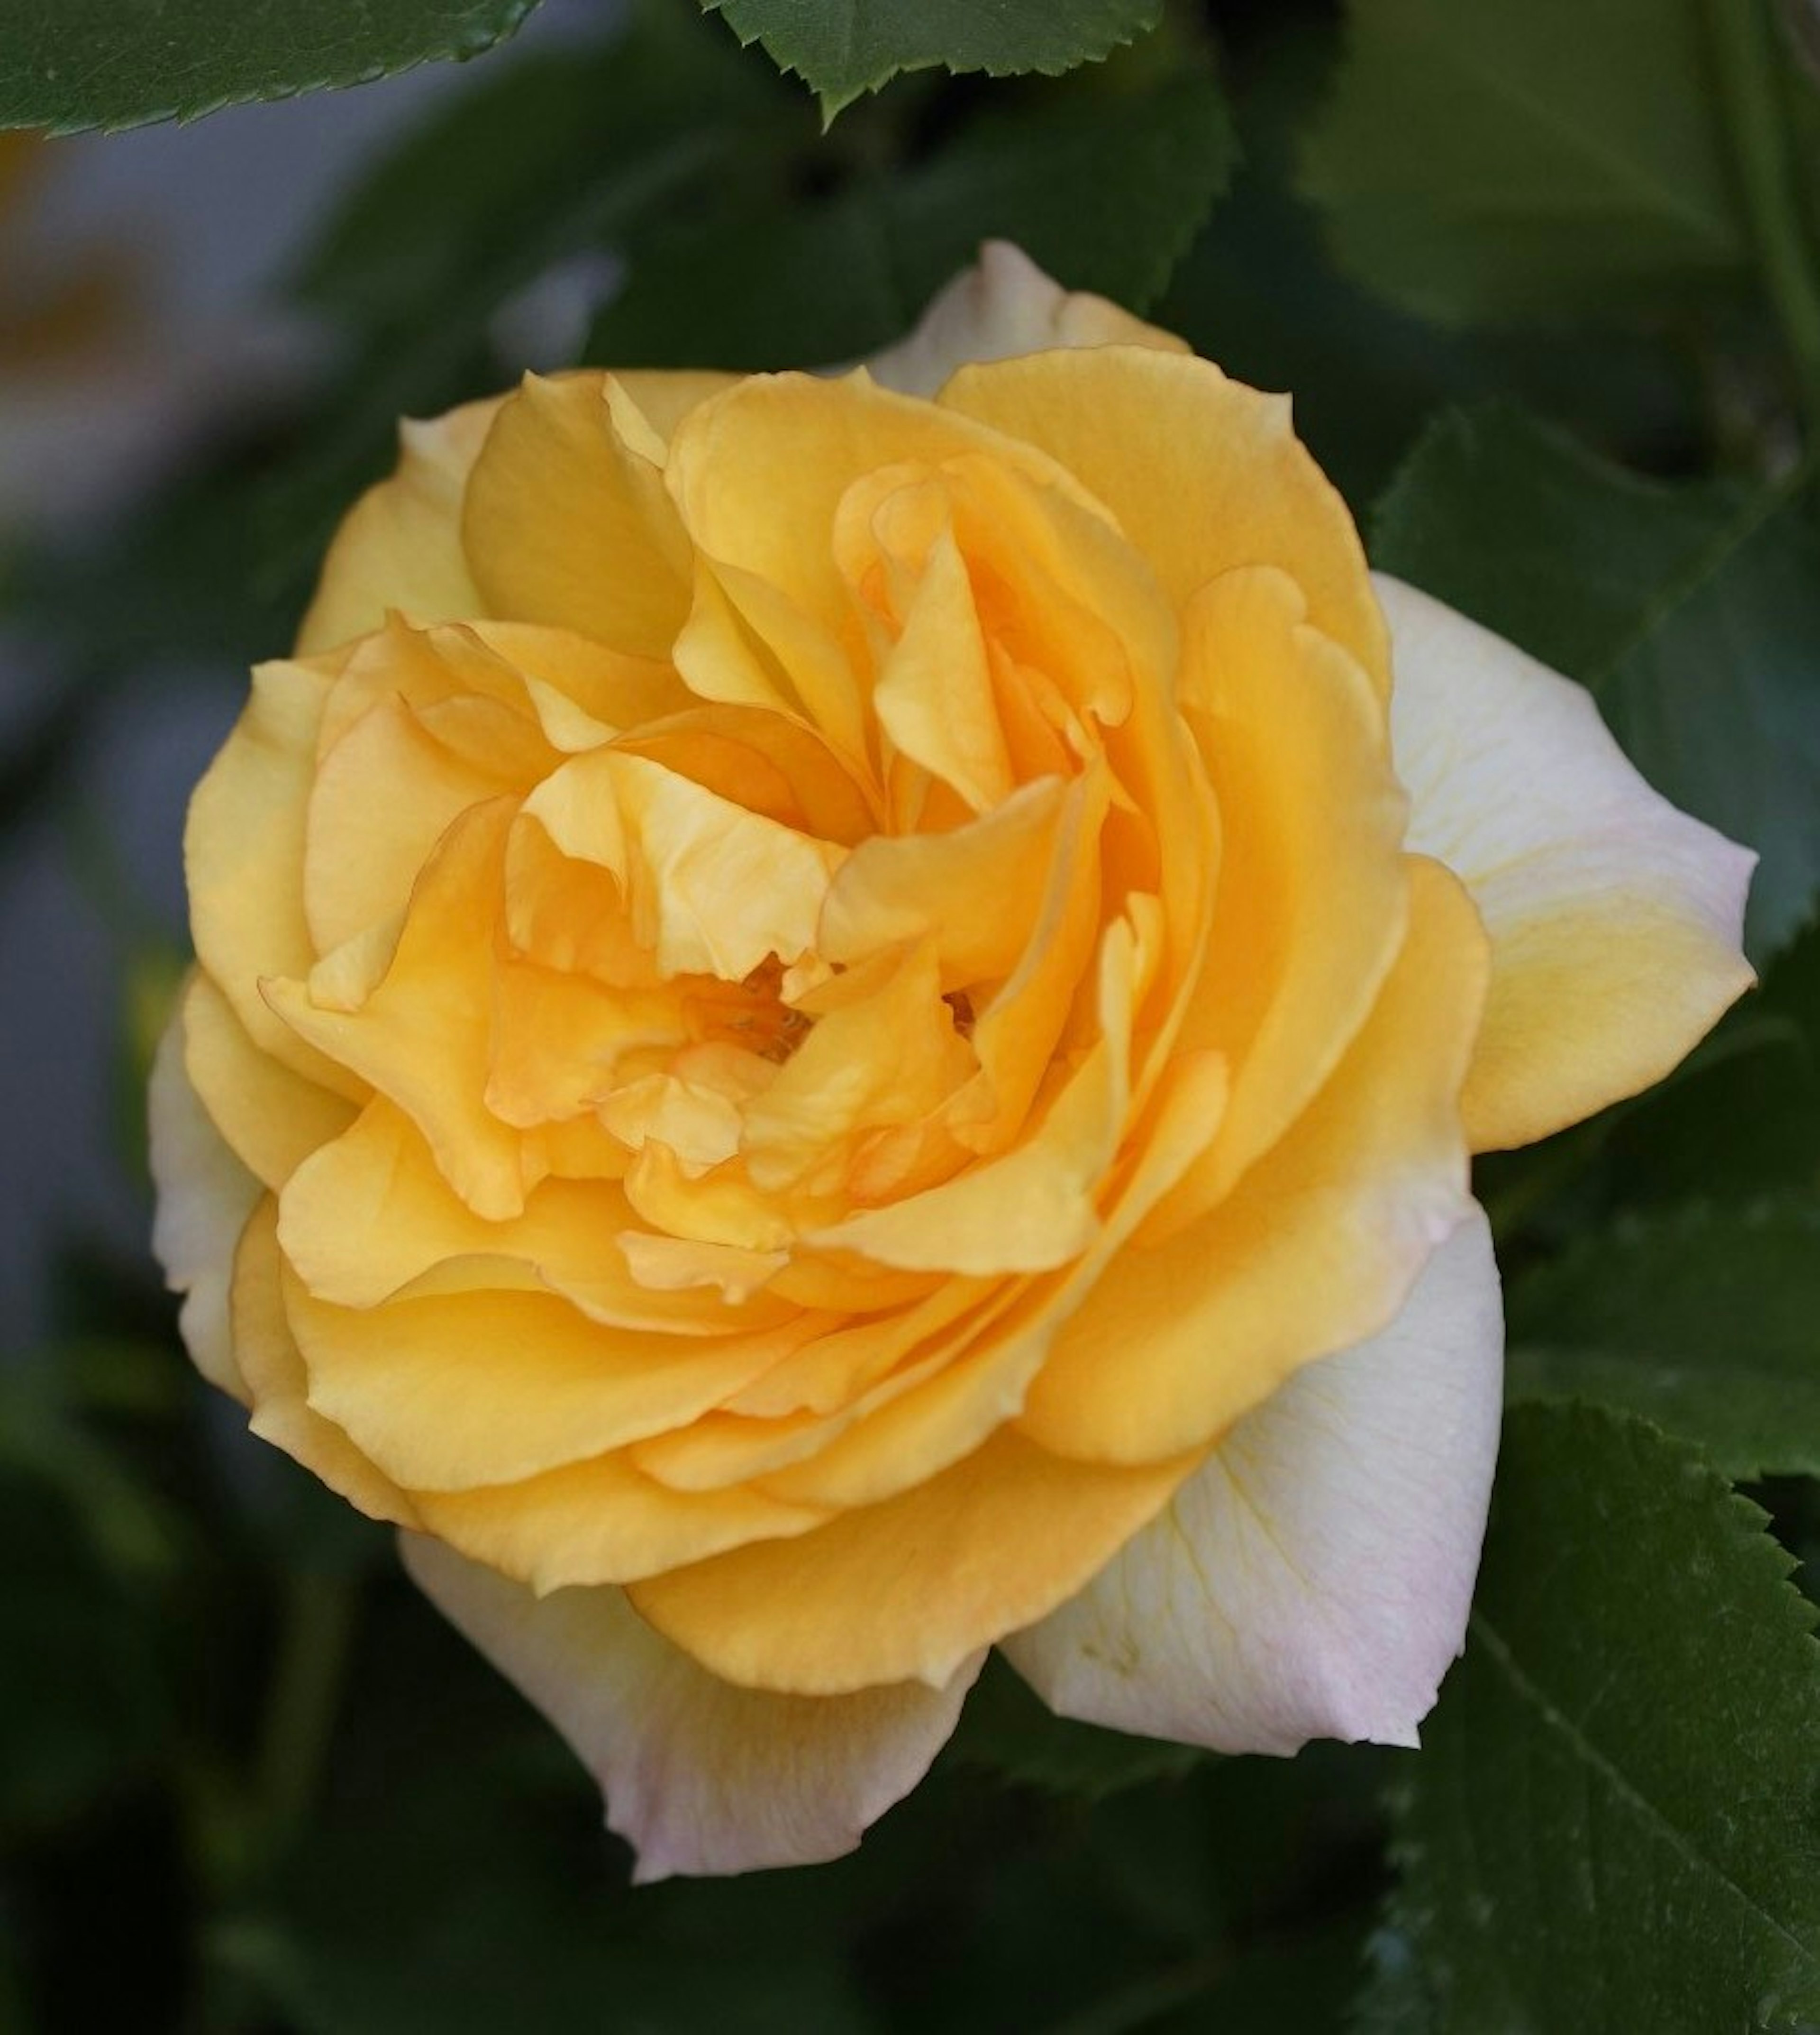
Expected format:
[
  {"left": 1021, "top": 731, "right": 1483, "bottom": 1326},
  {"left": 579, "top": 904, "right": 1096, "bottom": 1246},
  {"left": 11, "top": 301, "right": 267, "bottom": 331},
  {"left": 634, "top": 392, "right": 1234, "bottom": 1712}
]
[{"left": 0, "top": 0, "right": 617, "bottom": 1351}]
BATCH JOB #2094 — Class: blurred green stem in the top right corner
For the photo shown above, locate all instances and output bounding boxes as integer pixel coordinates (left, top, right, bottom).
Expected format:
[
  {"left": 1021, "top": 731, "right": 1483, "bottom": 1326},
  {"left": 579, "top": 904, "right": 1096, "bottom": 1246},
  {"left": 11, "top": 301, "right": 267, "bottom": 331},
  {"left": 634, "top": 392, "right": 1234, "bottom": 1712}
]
[{"left": 1706, "top": 0, "right": 1820, "bottom": 447}]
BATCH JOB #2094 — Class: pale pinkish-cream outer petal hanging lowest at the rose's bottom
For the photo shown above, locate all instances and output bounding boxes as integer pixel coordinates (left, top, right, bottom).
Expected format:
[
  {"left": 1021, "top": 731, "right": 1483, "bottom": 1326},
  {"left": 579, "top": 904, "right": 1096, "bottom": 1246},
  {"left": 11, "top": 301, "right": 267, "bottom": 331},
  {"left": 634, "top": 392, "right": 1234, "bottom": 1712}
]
[{"left": 401, "top": 1534, "right": 983, "bottom": 1880}]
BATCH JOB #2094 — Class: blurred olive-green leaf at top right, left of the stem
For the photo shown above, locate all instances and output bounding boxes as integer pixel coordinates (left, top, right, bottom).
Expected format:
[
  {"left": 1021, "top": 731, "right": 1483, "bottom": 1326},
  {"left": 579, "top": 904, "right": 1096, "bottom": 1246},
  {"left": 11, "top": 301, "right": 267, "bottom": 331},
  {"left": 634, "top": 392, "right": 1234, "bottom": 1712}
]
[{"left": 1301, "top": 0, "right": 1751, "bottom": 321}]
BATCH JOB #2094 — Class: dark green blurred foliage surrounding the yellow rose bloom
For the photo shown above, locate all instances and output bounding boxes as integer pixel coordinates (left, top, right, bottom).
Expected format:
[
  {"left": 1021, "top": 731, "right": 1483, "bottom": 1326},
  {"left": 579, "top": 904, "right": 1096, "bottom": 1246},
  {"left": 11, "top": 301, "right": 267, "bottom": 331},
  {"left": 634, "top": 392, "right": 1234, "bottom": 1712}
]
[{"left": 0, "top": 0, "right": 1820, "bottom": 2035}]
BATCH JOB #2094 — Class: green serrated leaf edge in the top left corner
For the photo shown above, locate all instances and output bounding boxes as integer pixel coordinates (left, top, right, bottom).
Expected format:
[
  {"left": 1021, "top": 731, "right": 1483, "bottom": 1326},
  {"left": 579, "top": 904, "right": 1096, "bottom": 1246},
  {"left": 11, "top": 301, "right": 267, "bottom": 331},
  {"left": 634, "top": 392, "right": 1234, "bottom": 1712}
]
[{"left": 0, "top": 0, "right": 537, "bottom": 134}]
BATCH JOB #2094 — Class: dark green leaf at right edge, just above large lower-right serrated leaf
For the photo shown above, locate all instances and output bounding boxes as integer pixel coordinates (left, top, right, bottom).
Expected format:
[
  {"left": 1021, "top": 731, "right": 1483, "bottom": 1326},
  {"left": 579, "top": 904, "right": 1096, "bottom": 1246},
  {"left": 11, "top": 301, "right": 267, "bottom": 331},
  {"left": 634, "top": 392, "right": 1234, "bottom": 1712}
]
[{"left": 1509, "top": 1201, "right": 1820, "bottom": 1478}]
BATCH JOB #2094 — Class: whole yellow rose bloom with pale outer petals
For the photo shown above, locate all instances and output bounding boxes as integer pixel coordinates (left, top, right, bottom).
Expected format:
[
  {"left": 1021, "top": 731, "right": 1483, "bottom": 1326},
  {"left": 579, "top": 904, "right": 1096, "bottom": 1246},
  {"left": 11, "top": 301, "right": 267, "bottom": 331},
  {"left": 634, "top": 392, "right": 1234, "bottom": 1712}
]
[{"left": 153, "top": 246, "right": 1751, "bottom": 1878}]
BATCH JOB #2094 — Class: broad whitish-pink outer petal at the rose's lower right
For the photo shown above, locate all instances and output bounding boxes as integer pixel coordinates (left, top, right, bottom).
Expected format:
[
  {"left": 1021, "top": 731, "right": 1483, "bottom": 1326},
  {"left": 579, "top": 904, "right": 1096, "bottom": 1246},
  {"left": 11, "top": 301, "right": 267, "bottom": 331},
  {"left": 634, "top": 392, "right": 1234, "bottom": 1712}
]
[{"left": 1004, "top": 1207, "right": 1504, "bottom": 1752}]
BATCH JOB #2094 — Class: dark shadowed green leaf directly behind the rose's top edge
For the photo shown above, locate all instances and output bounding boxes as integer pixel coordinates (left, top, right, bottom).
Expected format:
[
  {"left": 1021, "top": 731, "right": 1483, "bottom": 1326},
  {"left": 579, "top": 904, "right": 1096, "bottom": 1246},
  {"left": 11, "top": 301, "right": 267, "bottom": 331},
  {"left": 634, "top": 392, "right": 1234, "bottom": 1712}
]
[{"left": 586, "top": 67, "right": 1236, "bottom": 368}]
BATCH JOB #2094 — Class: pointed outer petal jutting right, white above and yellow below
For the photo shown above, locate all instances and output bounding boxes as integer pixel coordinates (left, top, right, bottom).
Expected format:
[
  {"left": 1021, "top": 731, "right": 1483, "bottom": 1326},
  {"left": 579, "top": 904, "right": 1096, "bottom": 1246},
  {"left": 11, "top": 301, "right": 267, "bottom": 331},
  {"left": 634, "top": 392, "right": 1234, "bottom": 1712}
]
[{"left": 1376, "top": 574, "right": 1755, "bottom": 1152}]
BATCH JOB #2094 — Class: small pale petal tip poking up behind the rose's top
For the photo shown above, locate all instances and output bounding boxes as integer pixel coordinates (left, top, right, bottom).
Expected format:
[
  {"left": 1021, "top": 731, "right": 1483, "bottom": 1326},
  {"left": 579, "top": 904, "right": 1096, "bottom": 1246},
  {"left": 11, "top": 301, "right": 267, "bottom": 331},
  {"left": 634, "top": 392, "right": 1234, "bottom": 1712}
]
[{"left": 867, "top": 240, "right": 1189, "bottom": 395}]
